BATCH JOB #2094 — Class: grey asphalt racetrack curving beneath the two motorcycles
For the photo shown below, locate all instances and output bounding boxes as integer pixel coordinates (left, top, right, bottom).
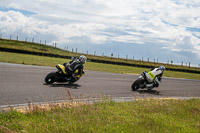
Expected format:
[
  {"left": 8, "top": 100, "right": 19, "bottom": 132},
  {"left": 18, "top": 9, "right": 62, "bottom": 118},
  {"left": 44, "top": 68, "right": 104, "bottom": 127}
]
[{"left": 0, "top": 63, "right": 200, "bottom": 106}]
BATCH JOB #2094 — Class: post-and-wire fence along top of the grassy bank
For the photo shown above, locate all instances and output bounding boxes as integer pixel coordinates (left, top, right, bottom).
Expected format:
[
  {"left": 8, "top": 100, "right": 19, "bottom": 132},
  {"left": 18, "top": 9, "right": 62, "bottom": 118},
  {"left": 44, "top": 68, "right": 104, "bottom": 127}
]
[{"left": 0, "top": 34, "right": 200, "bottom": 68}]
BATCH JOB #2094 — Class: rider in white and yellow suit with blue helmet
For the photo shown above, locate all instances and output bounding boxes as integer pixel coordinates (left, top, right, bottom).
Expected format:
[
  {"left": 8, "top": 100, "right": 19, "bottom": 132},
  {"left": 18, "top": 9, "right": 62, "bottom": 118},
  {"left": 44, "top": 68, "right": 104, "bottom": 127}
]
[{"left": 145, "top": 66, "right": 165, "bottom": 88}]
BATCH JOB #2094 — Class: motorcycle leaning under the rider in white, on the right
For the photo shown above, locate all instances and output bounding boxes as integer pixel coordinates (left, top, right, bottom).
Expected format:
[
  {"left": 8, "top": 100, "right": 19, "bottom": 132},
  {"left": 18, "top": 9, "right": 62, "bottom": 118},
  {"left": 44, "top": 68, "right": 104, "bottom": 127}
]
[{"left": 131, "top": 72, "right": 161, "bottom": 91}]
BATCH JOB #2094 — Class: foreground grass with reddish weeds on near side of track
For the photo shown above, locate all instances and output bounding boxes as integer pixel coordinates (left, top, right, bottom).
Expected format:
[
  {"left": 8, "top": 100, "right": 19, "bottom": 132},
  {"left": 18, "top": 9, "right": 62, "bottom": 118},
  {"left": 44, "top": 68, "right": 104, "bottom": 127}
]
[{"left": 0, "top": 99, "right": 200, "bottom": 133}]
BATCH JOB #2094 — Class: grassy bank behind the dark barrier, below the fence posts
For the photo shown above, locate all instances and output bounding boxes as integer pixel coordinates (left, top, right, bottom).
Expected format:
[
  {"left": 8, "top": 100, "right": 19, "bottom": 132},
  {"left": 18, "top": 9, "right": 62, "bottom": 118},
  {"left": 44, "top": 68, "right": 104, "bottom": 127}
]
[{"left": 0, "top": 39, "right": 200, "bottom": 71}]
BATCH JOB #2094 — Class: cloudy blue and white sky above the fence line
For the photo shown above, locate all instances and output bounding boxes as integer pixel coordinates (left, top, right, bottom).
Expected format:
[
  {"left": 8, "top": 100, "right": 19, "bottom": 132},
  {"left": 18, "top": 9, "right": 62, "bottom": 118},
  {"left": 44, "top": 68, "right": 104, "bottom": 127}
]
[{"left": 0, "top": 0, "right": 200, "bottom": 67}]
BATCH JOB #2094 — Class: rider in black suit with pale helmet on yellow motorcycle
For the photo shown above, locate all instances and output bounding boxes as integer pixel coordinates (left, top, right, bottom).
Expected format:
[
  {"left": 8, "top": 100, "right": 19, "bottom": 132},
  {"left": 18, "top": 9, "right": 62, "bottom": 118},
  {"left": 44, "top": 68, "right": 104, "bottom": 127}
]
[{"left": 61, "top": 55, "right": 87, "bottom": 80}]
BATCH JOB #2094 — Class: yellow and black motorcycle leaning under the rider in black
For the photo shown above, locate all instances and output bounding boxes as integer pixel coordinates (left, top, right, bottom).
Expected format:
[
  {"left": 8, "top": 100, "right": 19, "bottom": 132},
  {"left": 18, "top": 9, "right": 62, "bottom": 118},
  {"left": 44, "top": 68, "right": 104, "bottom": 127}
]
[{"left": 45, "top": 58, "right": 85, "bottom": 84}]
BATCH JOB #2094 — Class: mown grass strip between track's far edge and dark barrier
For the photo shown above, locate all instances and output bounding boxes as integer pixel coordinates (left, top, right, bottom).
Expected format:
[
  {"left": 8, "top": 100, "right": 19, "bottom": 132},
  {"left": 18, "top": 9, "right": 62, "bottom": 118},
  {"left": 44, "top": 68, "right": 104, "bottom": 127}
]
[{"left": 0, "top": 52, "right": 200, "bottom": 80}]
